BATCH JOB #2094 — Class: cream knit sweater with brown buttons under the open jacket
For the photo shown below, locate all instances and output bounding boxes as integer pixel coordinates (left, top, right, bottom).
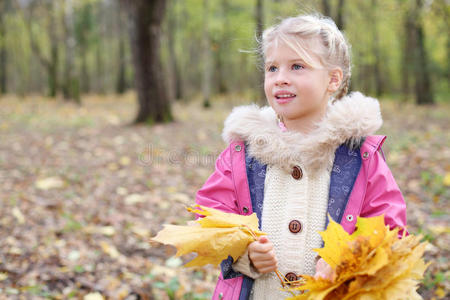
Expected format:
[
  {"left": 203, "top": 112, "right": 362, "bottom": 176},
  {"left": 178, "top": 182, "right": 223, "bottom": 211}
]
[{"left": 233, "top": 159, "right": 331, "bottom": 300}]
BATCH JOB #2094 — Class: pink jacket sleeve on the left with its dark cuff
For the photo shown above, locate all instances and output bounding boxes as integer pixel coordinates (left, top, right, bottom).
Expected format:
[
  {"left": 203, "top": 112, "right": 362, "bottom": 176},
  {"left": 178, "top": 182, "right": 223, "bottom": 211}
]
[{"left": 195, "top": 147, "right": 241, "bottom": 279}]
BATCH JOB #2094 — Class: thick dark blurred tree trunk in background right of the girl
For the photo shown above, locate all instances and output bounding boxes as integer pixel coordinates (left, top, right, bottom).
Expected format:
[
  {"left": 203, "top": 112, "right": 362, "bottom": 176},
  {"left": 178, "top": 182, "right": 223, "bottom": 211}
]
[{"left": 405, "top": 0, "right": 434, "bottom": 104}]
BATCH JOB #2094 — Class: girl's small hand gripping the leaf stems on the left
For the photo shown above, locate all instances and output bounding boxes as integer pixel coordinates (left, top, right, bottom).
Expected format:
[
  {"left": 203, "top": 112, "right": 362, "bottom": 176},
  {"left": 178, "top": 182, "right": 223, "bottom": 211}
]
[{"left": 248, "top": 236, "right": 277, "bottom": 274}]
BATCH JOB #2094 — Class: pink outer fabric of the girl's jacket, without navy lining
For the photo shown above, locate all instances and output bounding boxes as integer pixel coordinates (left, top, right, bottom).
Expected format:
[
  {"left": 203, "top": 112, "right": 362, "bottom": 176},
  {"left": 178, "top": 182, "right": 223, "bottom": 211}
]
[{"left": 196, "top": 136, "right": 406, "bottom": 300}]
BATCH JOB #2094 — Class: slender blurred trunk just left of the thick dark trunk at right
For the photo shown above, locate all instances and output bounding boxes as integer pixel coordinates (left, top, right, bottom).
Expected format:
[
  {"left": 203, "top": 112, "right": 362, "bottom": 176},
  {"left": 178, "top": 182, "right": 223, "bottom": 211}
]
[{"left": 369, "top": 0, "right": 387, "bottom": 97}]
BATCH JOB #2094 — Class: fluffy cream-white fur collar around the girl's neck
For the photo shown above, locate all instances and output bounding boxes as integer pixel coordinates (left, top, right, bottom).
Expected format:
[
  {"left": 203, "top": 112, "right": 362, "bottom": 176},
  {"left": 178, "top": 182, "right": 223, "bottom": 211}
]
[{"left": 222, "top": 92, "right": 383, "bottom": 173}]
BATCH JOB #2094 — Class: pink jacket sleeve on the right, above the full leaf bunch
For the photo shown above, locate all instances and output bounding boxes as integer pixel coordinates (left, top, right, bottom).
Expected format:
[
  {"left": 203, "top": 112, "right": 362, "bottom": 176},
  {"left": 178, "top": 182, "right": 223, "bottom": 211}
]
[{"left": 361, "top": 148, "right": 406, "bottom": 237}]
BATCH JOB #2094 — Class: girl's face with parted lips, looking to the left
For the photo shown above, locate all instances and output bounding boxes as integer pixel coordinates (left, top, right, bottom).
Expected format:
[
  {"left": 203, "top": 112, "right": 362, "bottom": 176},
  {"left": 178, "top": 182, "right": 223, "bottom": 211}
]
[{"left": 264, "top": 43, "right": 330, "bottom": 128}]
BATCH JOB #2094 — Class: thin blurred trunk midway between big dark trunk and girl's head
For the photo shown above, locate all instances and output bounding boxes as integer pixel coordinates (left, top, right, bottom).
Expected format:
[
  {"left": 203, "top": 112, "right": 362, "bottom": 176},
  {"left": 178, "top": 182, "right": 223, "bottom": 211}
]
[{"left": 202, "top": 0, "right": 211, "bottom": 107}]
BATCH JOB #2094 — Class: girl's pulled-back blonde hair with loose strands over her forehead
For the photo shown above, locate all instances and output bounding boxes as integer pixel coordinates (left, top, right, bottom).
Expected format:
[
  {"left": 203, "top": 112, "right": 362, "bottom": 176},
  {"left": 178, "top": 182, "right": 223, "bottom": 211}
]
[{"left": 260, "top": 14, "right": 351, "bottom": 99}]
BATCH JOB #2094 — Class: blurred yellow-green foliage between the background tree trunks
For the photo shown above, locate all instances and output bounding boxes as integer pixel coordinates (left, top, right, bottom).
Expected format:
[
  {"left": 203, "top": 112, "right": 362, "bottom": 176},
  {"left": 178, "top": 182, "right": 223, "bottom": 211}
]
[{"left": 0, "top": 0, "right": 450, "bottom": 101}]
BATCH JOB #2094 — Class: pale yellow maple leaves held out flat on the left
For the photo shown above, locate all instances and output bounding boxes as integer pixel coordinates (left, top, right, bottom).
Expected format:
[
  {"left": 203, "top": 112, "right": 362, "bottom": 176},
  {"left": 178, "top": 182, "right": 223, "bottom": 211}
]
[{"left": 151, "top": 205, "right": 265, "bottom": 267}]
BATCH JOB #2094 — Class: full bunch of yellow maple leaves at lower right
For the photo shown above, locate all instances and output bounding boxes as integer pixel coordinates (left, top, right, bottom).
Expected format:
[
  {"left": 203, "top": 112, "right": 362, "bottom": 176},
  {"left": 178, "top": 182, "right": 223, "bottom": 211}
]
[{"left": 289, "top": 216, "right": 428, "bottom": 300}]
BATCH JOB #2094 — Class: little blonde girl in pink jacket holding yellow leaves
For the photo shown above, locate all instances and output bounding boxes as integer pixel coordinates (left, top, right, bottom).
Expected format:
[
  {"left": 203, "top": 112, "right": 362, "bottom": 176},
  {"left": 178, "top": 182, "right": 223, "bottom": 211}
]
[{"left": 196, "top": 15, "right": 406, "bottom": 300}]
